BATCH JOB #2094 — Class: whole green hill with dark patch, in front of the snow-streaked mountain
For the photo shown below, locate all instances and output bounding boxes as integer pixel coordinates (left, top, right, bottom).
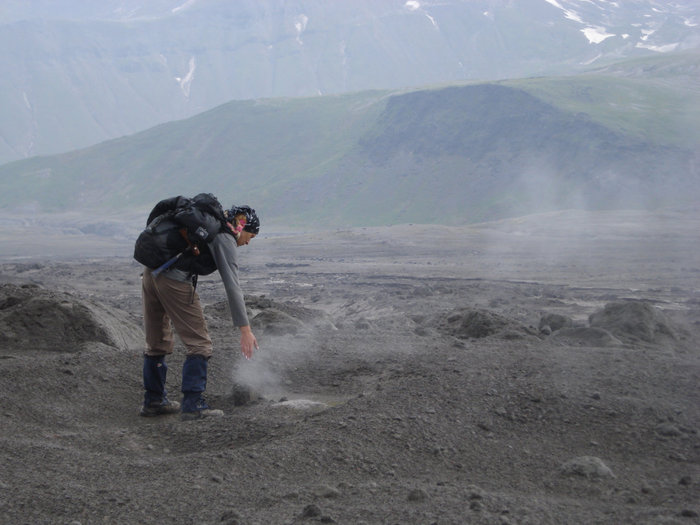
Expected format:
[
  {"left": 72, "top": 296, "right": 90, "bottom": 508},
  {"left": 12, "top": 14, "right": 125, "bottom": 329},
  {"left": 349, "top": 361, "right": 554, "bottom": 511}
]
[{"left": 0, "top": 53, "right": 700, "bottom": 228}]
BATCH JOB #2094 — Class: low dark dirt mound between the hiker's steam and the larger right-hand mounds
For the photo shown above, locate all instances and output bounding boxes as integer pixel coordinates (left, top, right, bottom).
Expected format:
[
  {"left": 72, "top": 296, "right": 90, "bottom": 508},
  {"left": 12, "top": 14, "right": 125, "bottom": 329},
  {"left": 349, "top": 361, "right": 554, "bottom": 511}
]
[{"left": 437, "top": 308, "right": 530, "bottom": 339}]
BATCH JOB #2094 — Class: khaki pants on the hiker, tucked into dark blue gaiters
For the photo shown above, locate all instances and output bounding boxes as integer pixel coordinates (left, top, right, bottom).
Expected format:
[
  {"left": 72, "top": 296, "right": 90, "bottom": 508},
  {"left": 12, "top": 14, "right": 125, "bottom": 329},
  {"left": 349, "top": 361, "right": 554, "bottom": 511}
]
[{"left": 141, "top": 269, "right": 212, "bottom": 358}]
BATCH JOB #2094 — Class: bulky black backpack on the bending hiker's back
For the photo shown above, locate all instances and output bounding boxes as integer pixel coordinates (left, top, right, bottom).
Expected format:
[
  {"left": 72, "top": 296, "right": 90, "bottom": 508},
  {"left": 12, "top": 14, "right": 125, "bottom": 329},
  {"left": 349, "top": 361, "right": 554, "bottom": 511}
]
[{"left": 134, "top": 193, "right": 231, "bottom": 275}]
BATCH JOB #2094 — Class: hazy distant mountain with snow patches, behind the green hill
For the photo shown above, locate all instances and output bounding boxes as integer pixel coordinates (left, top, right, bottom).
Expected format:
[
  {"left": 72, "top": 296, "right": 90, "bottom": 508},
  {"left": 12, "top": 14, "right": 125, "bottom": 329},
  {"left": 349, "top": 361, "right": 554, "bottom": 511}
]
[{"left": 0, "top": 0, "right": 700, "bottom": 163}]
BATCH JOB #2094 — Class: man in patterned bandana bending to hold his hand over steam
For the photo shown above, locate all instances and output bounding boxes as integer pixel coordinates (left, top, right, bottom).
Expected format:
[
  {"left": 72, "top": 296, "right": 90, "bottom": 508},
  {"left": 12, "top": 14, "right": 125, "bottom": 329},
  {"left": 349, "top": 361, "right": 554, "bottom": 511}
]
[{"left": 137, "top": 199, "right": 260, "bottom": 420}]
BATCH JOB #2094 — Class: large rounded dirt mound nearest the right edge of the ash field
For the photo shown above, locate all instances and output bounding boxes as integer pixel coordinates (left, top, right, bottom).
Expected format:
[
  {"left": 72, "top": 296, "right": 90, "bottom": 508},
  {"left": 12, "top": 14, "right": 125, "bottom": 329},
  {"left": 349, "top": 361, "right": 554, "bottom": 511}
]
[{"left": 588, "top": 301, "right": 677, "bottom": 343}]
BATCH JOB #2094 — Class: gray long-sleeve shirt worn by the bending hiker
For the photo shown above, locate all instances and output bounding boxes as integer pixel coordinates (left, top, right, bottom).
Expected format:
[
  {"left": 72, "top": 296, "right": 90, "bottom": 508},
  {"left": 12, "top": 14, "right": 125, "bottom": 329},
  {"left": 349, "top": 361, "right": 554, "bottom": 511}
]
[{"left": 163, "top": 232, "right": 249, "bottom": 326}]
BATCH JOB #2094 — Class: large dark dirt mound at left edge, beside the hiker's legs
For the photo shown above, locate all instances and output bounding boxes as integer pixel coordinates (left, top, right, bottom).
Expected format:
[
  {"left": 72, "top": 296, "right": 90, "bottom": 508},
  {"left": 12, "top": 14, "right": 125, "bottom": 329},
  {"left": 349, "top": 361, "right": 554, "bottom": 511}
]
[{"left": 0, "top": 284, "right": 143, "bottom": 353}]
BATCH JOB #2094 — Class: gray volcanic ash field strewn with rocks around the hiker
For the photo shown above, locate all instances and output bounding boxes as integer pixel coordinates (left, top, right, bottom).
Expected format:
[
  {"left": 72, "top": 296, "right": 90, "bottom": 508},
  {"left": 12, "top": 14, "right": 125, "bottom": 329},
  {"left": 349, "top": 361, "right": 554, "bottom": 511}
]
[{"left": 0, "top": 212, "right": 700, "bottom": 525}]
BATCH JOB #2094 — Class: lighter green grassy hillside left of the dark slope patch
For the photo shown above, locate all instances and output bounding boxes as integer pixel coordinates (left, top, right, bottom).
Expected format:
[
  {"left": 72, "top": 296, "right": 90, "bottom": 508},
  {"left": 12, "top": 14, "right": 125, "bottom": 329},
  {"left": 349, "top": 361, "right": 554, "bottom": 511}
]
[{"left": 0, "top": 92, "right": 384, "bottom": 211}]
